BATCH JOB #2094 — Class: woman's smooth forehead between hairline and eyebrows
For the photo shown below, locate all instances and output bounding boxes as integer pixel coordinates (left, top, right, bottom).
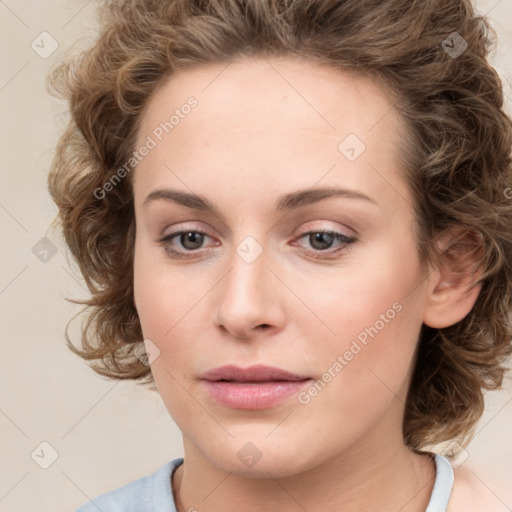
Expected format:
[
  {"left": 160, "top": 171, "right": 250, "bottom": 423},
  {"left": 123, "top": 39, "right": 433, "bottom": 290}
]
[{"left": 134, "top": 58, "right": 412, "bottom": 214}]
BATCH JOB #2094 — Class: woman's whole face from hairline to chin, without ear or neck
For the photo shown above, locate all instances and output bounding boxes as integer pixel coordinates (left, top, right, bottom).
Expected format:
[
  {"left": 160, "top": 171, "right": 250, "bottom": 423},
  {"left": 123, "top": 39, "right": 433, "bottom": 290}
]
[{"left": 133, "top": 58, "right": 427, "bottom": 476}]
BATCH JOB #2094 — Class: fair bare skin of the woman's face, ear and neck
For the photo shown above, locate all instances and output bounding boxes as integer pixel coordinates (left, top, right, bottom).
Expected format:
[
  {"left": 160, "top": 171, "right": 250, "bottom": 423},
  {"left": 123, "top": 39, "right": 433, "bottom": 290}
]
[{"left": 133, "top": 58, "right": 479, "bottom": 512}]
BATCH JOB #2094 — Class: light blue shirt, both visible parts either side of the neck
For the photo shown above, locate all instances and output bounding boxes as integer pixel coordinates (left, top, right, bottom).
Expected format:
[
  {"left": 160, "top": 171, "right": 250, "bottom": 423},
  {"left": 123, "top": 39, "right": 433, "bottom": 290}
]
[{"left": 76, "top": 454, "right": 453, "bottom": 512}]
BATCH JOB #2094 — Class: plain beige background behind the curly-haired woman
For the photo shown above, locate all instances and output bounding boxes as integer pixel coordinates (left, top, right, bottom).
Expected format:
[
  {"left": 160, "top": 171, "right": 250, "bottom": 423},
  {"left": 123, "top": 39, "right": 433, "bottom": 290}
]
[{"left": 0, "top": 0, "right": 512, "bottom": 512}]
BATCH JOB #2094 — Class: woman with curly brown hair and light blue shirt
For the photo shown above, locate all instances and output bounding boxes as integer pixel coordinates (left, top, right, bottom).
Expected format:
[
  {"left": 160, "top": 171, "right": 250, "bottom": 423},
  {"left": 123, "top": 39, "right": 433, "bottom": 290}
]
[{"left": 49, "top": 0, "right": 512, "bottom": 512}]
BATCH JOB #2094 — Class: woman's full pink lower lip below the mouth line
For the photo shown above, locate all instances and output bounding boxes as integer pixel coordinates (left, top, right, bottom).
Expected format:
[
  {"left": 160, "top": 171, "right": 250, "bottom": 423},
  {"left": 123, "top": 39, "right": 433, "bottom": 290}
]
[{"left": 204, "top": 379, "right": 311, "bottom": 409}]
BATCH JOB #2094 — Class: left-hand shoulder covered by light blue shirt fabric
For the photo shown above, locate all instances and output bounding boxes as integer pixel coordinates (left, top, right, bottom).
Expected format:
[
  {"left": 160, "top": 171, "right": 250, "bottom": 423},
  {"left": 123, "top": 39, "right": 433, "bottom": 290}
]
[{"left": 76, "top": 458, "right": 183, "bottom": 512}]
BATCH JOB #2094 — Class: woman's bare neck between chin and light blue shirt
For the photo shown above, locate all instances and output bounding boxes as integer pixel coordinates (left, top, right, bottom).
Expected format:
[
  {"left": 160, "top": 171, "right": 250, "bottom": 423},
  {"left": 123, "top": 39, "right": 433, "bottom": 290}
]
[{"left": 172, "top": 437, "right": 436, "bottom": 512}]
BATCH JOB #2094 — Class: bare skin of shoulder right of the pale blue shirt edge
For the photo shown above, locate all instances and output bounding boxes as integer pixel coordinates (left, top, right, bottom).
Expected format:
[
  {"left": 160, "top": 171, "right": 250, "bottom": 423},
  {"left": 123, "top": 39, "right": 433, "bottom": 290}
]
[{"left": 447, "top": 464, "right": 509, "bottom": 512}]
